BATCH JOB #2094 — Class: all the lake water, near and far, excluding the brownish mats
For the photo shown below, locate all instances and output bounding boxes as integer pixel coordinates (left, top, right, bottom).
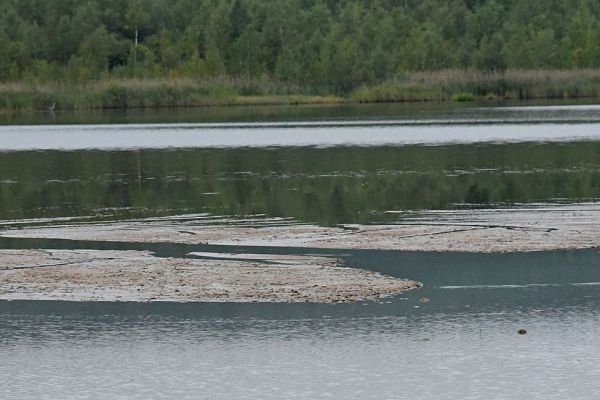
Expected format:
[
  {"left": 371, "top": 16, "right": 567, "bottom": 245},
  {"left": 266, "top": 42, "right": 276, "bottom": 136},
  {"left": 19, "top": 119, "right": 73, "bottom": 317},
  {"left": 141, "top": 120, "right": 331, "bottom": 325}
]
[{"left": 0, "top": 104, "right": 600, "bottom": 400}]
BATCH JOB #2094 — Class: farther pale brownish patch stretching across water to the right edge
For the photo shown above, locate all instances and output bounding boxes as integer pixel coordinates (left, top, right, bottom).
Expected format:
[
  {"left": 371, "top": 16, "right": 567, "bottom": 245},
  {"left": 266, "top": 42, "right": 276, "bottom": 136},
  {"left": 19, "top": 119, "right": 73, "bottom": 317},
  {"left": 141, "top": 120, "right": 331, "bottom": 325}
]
[{"left": 0, "top": 203, "right": 600, "bottom": 253}]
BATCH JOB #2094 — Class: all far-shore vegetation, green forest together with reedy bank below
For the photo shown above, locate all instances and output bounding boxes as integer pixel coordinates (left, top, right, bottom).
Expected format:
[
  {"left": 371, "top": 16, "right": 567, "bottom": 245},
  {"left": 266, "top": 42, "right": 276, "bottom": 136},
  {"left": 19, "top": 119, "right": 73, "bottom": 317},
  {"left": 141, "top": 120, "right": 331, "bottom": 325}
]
[{"left": 0, "top": 0, "right": 600, "bottom": 112}]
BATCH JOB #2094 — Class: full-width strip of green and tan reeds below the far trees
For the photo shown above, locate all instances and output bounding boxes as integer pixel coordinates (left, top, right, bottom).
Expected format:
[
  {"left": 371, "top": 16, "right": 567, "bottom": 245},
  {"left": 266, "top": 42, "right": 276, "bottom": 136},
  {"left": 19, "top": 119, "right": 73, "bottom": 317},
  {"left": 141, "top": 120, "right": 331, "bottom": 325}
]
[{"left": 0, "top": 69, "right": 600, "bottom": 112}]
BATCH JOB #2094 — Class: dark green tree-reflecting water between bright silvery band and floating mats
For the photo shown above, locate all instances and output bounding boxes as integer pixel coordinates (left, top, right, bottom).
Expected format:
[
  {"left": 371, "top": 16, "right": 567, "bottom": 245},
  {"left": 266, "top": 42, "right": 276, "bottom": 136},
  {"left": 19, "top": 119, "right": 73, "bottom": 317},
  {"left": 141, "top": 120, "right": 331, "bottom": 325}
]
[{"left": 0, "top": 142, "right": 600, "bottom": 224}]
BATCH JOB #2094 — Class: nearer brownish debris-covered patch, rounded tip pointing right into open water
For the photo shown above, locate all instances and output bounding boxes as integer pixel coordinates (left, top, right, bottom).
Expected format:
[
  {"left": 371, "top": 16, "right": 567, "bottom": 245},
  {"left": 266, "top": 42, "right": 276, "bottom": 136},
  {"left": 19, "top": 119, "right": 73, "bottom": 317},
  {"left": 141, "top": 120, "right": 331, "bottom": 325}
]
[{"left": 0, "top": 250, "right": 421, "bottom": 303}]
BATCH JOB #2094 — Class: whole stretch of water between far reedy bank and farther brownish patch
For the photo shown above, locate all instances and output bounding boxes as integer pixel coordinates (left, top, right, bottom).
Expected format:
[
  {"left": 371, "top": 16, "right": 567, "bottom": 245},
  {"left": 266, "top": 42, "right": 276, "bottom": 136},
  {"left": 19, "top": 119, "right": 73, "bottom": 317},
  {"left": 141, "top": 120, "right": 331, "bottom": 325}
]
[{"left": 0, "top": 101, "right": 600, "bottom": 225}]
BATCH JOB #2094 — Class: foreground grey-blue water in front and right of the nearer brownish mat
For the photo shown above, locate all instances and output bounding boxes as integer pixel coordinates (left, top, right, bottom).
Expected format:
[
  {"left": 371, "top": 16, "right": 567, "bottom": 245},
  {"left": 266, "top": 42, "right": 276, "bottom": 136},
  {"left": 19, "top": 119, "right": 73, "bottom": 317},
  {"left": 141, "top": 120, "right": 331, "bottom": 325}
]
[{"left": 0, "top": 249, "right": 600, "bottom": 399}]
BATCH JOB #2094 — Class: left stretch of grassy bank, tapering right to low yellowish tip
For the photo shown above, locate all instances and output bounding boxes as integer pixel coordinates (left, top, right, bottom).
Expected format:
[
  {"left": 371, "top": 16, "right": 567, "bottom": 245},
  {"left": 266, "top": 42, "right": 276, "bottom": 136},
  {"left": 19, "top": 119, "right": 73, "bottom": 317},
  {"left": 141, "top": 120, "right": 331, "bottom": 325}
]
[{"left": 0, "top": 79, "right": 341, "bottom": 111}]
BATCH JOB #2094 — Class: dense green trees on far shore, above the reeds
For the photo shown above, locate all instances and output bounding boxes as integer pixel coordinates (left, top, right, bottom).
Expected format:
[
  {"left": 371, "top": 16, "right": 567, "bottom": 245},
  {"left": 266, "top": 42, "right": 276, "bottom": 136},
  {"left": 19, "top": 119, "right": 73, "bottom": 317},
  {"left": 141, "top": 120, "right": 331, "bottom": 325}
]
[{"left": 0, "top": 0, "right": 600, "bottom": 94}]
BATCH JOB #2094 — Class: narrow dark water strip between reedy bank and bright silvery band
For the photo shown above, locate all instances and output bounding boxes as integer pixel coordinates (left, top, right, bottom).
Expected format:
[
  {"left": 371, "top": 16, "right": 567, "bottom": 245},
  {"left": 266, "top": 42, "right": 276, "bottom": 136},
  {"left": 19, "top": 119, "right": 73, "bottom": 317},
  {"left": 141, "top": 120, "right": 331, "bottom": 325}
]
[{"left": 0, "top": 99, "right": 600, "bottom": 125}]
